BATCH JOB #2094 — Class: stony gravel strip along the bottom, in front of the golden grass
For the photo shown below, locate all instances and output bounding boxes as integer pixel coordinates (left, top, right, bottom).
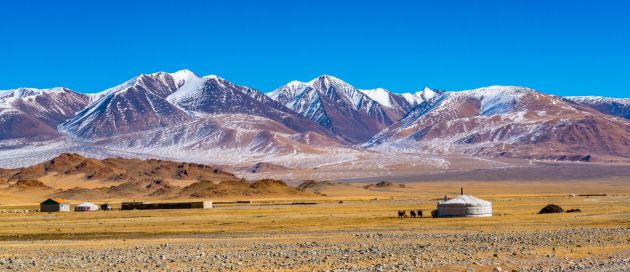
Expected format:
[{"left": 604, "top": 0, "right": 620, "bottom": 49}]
[{"left": 0, "top": 227, "right": 630, "bottom": 271}]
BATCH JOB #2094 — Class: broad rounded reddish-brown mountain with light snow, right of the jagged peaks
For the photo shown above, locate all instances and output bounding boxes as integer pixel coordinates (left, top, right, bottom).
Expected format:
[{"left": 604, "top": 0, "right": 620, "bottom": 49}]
[{"left": 363, "top": 86, "right": 630, "bottom": 160}]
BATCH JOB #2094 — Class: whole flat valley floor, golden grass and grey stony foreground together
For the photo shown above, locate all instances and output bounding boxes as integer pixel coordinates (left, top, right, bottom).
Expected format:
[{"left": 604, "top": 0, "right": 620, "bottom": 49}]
[{"left": 0, "top": 179, "right": 630, "bottom": 271}]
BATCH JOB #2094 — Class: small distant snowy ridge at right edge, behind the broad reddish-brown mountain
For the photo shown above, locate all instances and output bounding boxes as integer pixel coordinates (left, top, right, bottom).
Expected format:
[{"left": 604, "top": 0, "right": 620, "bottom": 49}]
[{"left": 565, "top": 96, "right": 630, "bottom": 119}]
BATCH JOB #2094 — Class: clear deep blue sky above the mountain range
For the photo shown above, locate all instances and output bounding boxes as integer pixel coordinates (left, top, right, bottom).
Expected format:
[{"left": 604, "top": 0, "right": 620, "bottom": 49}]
[{"left": 0, "top": 0, "right": 630, "bottom": 97}]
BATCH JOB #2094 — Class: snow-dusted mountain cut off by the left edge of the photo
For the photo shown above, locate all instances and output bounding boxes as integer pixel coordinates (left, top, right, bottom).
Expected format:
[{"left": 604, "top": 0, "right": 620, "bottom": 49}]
[{"left": 0, "top": 88, "right": 89, "bottom": 140}]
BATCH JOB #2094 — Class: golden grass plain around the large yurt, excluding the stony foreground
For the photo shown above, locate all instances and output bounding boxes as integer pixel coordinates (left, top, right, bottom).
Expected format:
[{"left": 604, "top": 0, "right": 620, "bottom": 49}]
[{"left": 0, "top": 183, "right": 630, "bottom": 239}]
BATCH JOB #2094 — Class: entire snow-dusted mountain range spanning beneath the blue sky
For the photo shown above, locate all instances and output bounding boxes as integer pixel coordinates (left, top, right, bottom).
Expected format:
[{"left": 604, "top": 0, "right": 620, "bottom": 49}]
[{"left": 0, "top": 70, "right": 630, "bottom": 167}]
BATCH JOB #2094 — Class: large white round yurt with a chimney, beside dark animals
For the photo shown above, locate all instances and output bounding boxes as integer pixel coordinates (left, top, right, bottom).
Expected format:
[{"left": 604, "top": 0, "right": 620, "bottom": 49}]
[{"left": 437, "top": 194, "right": 492, "bottom": 217}]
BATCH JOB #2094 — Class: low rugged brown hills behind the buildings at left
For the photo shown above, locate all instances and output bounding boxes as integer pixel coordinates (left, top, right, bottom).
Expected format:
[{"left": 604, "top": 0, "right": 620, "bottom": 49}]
[{"left": 0, "top": 154, "right": 312, "bottom": 200}]
